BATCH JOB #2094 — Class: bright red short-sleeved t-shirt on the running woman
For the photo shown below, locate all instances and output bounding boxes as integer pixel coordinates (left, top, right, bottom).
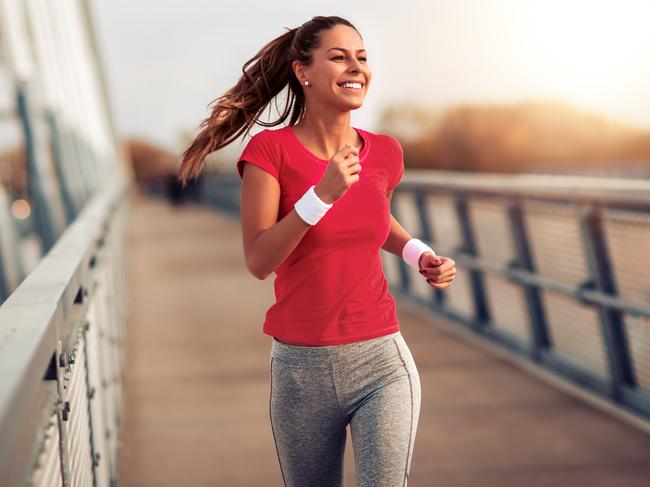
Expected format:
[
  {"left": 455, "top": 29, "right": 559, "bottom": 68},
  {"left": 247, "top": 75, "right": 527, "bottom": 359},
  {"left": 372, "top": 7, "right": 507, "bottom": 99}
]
[{"left": 237, "top": 126, "right": 404, "bottom": 345}]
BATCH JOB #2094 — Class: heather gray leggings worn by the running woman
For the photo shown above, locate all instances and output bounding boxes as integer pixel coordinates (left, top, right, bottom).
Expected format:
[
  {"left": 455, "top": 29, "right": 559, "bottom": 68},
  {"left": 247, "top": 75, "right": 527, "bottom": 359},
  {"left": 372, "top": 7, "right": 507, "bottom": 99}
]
[{"left": 269, "top": 331, "right": 421, "bottom": 487}]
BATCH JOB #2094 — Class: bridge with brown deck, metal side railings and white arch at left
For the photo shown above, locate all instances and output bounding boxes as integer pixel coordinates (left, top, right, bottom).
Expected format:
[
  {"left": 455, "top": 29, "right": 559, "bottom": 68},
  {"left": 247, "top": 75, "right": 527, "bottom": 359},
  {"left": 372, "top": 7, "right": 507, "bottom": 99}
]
[{"left": 0, "top": 0, "right": 650, "bottom": 487}]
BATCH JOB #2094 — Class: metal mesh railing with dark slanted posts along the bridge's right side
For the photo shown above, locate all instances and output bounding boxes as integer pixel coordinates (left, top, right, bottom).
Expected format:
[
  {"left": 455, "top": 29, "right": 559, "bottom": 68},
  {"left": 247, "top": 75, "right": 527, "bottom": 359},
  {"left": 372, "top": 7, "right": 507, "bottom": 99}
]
[{"left": 382, "top": 170, "right": 650, "bottom": 424}]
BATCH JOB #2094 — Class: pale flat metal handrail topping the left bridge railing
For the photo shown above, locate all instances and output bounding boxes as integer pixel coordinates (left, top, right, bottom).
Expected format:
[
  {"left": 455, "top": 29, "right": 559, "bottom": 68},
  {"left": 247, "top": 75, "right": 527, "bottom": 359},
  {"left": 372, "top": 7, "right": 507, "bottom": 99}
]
[{"left": 0, "top": 173, "right": 127, "bottom": 465}]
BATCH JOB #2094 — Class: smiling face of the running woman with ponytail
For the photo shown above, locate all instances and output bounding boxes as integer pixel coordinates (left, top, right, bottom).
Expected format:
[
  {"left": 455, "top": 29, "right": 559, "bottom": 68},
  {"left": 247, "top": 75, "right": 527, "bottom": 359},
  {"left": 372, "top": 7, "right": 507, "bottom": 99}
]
[{"left": 293, "top": 25, "right": 372, "bottom": 111}]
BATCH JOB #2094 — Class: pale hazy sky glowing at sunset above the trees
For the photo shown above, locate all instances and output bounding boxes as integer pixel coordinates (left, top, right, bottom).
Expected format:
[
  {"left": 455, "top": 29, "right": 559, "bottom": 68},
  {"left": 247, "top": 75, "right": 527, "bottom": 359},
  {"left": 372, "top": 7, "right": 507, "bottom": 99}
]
[{"left": 90, "top": 0, "right": 650, "bottom": 151}]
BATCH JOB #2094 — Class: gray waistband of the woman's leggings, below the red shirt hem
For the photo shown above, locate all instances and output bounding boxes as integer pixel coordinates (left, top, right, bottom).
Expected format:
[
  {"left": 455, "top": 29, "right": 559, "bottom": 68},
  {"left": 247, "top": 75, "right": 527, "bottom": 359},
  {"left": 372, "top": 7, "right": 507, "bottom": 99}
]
[{"left": 271, "top": 330, "right": 402, "bottom": 364}]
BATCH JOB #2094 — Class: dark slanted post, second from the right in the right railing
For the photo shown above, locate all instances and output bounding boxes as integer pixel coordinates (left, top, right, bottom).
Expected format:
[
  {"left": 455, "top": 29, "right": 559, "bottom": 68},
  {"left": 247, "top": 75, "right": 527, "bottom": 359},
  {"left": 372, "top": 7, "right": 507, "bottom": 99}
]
[{"left": 506, "top": 199, "right": 550, "bottom": 362}]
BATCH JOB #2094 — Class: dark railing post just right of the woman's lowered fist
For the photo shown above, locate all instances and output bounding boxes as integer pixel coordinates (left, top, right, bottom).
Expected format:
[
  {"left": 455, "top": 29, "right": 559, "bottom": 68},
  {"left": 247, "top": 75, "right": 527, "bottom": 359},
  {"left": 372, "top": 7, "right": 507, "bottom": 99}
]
[{"left": 453, "top": 192, "right": 490, "bottom": 329}]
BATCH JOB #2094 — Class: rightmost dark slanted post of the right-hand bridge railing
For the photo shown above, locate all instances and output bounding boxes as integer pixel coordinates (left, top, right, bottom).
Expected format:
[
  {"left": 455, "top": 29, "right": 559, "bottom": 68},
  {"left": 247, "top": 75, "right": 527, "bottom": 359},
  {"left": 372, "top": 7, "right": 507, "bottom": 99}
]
[{"left": 578, "top": 204, "right": 635, "bottom": 400}]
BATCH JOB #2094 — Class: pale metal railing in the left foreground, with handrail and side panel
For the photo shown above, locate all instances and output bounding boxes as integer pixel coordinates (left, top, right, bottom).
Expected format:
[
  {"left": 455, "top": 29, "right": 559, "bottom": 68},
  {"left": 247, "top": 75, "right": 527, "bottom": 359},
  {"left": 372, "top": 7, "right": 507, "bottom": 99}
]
[{"left": 0, "top": 174, "right": 129, "bottom": 486}]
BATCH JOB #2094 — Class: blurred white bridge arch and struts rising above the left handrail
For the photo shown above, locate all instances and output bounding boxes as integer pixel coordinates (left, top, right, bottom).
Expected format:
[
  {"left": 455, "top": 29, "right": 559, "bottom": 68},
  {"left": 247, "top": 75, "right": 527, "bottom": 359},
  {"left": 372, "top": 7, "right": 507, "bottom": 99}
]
[{"left": 0, "top": 0, "right": 129, "bottom": 303}]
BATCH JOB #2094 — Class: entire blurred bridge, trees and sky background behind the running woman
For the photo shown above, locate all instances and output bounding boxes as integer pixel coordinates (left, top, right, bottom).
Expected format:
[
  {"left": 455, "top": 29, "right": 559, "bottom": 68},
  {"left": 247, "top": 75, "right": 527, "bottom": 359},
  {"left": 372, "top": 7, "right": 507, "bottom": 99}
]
[{"left": 0, "top": 0, "right": 650, "bottom": 487}]
